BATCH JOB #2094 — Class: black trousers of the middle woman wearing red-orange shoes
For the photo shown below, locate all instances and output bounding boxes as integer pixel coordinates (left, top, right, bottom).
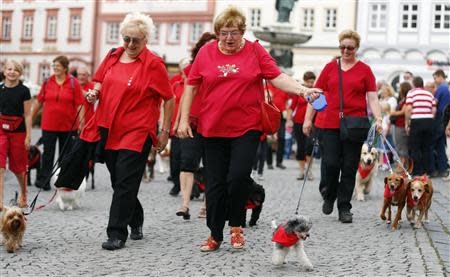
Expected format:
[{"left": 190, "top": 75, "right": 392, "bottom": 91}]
[{"left": 204, "top": 131, "right": 261, "bottom": 241}]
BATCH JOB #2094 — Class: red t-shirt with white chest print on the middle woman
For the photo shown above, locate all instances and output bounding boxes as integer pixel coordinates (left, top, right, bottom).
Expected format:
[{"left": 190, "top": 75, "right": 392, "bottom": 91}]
[{"left": 188, "top": 41, "right": 281, "bottom": 137}]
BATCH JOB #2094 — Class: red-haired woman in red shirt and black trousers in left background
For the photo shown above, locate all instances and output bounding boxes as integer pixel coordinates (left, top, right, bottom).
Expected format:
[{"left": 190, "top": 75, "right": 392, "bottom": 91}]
[{"left": 32, "top": 56, "right": 84, "bottom": 190}]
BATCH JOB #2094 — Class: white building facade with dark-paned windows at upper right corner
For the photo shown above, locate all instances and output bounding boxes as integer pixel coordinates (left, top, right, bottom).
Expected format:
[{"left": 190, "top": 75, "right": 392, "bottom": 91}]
[{"left": 357, "top": 0, "right": 450, "bottom": 87}]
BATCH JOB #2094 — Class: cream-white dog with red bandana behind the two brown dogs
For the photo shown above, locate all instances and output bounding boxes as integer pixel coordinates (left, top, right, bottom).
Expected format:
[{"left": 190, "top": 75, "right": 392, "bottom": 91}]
[{"left": 355, "top": 143, "right": 378, "bottom": 201}]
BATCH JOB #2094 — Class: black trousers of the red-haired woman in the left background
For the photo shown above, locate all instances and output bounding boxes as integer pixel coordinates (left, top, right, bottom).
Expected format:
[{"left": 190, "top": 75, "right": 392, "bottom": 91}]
[{"left": 37, "top": 130, "right": 75, "bottom": 185}]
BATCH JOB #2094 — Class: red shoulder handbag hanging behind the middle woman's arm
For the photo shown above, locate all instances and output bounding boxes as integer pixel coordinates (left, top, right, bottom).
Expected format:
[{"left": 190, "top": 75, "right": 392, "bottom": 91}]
[{"left": 261, "top": 81, "right": 281, "bottom": 135}]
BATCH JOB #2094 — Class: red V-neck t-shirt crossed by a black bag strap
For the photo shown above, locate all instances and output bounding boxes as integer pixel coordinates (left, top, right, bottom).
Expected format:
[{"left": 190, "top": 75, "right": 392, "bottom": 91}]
[{"left": 315, "top": 60, "right": 376, "bottom": 129}]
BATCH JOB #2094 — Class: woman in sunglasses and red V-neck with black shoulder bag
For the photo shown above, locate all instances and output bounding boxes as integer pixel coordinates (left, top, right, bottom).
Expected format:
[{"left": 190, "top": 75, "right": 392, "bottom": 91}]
[{"left": 303, "top": 30, "right": 381, "bottom": 223}]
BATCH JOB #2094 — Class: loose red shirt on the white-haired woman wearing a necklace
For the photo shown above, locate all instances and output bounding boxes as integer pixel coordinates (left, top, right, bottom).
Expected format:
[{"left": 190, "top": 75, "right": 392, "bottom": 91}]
[{"left": 81, "top": 47, "right": 173, "bottom": 152}]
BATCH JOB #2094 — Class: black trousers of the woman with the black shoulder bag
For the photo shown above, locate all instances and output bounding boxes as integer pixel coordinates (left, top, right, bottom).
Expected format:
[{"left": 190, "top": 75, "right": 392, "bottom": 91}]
[{"left": 321, "top": 129, "right": 363, "bottom": 211}]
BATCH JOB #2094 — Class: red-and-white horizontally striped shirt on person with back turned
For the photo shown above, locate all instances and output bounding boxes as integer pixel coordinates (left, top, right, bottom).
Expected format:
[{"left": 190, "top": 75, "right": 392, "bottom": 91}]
[{"left": 406, "top": 88, "right": 436, "bottom": 119}]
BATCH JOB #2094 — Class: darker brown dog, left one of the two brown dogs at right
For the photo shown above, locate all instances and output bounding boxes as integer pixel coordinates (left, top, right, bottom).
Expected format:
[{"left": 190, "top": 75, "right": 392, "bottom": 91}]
[{"left": 380, "top": 173, "right": 406, "bottom": 230}]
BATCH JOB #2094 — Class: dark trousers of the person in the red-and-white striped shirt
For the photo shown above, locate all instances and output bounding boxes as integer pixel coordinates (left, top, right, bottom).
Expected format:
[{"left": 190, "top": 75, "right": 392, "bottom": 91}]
[{"left": 408, "top": 118, "right": 434, "bottom": 176}]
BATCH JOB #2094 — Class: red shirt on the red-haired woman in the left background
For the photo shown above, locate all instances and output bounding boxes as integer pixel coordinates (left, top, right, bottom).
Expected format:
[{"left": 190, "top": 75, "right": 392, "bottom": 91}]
[{"left": 37, "top": 74, "right": 84, "bottom": 132}]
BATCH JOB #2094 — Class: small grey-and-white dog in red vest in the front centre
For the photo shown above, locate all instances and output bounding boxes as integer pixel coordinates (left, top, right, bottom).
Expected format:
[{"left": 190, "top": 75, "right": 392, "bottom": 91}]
[{"left": 272, "top": 216, "right": 313, "bottom": 271}]
